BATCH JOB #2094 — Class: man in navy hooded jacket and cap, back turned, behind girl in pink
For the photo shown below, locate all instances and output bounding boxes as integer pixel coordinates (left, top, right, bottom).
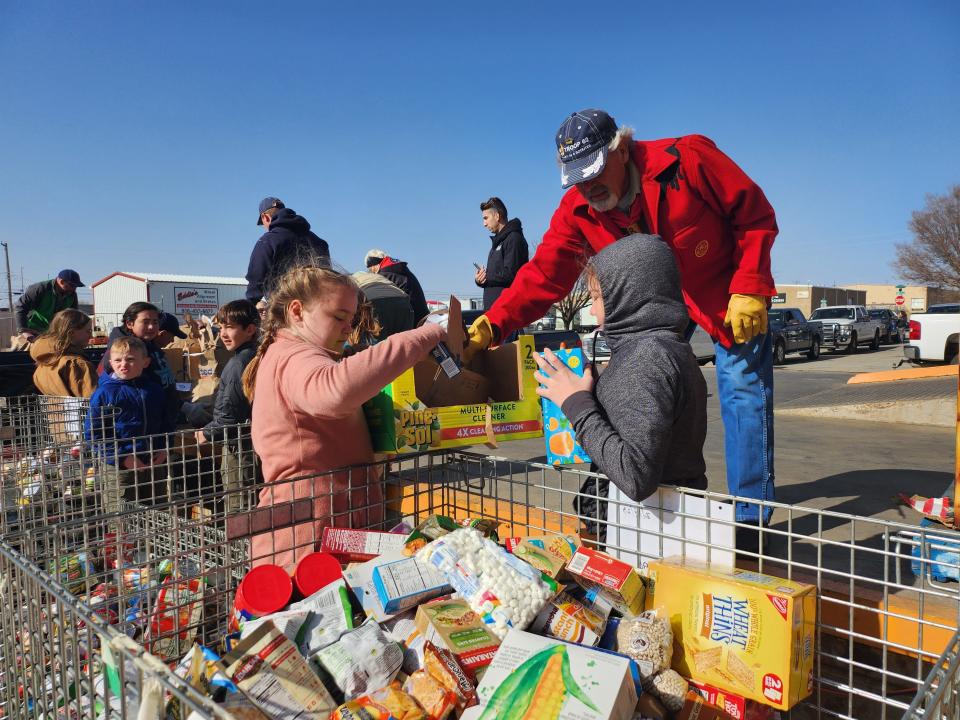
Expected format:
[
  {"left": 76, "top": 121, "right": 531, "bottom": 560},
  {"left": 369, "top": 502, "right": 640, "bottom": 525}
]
[{"left": 247, "top": 197, "right": 330, "bottom": 303}]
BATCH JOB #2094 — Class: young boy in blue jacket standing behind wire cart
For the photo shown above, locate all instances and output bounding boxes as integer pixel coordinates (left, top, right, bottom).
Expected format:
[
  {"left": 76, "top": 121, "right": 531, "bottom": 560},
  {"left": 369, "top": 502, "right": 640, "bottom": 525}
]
[{"left": 84, "top": 336, "right": 174, "bottom": 512}]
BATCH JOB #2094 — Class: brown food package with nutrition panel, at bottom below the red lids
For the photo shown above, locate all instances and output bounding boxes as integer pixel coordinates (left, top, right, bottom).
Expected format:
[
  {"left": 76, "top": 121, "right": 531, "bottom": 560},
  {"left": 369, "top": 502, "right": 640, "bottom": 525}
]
[{"left": 223, "top": 622, "right": 337, "bottom": 720}]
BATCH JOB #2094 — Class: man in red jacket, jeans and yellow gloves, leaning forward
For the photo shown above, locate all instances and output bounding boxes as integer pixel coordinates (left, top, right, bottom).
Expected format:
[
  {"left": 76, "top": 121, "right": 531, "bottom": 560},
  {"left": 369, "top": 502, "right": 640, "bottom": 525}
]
[{"left": 467, "top": 109, "right": 777, "bottom": 536}]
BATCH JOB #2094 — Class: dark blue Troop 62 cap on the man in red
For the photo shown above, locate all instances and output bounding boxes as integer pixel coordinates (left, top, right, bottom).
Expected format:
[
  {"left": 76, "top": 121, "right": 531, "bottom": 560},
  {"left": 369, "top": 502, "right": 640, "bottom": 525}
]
[{"left": 557, "top": 108, "right": 617, "bottom": 190}]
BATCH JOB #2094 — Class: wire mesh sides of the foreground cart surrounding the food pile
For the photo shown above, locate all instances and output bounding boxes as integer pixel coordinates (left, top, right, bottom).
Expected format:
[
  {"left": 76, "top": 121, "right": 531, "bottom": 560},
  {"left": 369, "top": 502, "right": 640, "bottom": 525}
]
[{"left": 0, "top": 452, "right": 960, "bottom": 720}]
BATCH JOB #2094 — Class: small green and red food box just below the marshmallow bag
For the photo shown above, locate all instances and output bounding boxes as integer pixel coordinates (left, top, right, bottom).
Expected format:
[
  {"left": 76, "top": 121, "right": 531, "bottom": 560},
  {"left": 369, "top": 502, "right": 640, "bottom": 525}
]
[{"left": 416, "top": 599, "right": 500, "bottom": 672}]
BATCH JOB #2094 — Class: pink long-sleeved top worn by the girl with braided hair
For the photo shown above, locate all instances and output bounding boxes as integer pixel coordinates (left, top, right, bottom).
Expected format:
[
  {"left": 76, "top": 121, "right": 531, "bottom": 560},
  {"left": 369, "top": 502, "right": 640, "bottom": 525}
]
[{"left": 250, "top": 325, "right": 445, "bottom": 570}]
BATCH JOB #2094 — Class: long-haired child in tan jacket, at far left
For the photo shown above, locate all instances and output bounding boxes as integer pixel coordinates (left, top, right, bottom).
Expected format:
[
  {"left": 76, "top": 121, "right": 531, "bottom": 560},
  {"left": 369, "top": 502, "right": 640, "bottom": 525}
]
[{"left": 30, "top": 309, "right": 97, "bottom": 398}]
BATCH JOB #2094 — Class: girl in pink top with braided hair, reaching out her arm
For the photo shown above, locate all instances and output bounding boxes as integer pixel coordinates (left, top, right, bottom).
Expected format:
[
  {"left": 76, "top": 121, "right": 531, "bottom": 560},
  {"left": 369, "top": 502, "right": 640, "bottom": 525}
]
[{"left": 243, "top": 267, "right": 446, "bottom": 569}]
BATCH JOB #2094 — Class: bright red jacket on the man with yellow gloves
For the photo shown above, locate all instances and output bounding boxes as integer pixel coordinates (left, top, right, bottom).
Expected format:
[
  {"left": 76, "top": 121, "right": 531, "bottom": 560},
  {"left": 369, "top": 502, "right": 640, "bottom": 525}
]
[{"left": 487, "top": 135, "right": 777, "bottom": 347}]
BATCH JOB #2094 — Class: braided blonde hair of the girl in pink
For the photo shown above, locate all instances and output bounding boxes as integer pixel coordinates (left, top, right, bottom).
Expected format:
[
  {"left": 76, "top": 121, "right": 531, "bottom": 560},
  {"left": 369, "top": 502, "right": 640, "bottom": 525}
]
[{"left": 243, "top": 267, "right": 360, "bottom": 402}]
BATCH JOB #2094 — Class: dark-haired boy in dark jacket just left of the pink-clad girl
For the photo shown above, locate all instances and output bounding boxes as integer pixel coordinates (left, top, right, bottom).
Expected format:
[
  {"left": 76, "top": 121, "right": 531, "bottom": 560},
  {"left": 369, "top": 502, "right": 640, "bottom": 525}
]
[{"left": 196, "top": 300, "right": 260, "bottom": 513}]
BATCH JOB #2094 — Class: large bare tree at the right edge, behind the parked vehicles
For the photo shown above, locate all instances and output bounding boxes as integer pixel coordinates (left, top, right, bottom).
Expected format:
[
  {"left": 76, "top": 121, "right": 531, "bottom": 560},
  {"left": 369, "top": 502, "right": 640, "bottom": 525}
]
[{"left": 893, "top": 185, "right": 960, "bottom": 289}]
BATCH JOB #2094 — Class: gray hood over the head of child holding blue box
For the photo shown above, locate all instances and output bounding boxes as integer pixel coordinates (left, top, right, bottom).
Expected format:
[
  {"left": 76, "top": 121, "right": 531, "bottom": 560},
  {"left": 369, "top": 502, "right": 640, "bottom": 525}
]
[{"left": 590, "top": 234, "right": 690, "bottom": 350}]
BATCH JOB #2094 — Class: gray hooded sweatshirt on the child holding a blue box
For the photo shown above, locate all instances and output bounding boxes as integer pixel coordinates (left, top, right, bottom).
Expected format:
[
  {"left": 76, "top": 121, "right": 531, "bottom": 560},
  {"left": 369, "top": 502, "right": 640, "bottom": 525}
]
[{"left": 562, "top": 235, "right": 707, "bottom": 501}]
